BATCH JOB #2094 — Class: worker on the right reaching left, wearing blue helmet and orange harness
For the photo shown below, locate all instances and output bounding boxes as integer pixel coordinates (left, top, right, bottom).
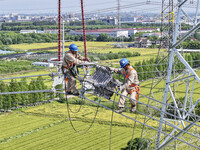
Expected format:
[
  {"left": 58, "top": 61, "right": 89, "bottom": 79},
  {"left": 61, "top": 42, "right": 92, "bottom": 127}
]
[{"left": 108, "top": 58, "right": 140, "bottom": 113}]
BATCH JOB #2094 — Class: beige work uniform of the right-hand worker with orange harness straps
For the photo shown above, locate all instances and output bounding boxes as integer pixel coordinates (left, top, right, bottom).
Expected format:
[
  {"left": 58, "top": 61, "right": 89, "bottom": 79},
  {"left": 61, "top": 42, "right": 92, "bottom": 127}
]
[{"left": 110, "top": 66, "right": 139, "bottom": 108}]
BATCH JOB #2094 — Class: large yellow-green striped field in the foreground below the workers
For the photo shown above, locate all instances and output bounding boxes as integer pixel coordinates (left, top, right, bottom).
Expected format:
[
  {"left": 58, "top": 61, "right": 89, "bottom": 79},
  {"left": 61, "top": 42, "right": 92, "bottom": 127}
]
[{"left": 0, "top": 102, "right": 198, "bottom": 150}]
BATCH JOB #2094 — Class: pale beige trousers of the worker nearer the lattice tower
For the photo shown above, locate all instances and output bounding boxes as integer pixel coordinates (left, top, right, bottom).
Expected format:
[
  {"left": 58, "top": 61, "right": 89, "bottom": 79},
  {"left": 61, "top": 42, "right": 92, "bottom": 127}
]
[{"left": 119, "top": 89, "right": 137, "bottom": 107}]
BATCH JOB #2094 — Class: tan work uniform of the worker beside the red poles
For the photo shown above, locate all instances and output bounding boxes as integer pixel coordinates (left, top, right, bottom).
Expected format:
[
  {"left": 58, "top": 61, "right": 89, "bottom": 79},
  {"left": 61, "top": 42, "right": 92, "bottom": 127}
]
[{"left": 62, "top": 51, "right": 86, "bottom": 93}]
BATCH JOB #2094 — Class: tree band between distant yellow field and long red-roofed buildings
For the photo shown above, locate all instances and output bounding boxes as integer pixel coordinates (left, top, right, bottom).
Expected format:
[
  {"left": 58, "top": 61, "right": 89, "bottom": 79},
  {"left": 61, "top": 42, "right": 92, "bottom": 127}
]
[{"left": 0, "top": 32, "right": 200, "bottom": 49}]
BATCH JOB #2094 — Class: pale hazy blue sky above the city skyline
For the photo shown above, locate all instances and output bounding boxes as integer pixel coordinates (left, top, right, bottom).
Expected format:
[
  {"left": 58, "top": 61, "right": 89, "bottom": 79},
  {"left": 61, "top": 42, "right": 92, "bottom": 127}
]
[{"left": 0, "top": 0, "right": 196, "bottom": 14}]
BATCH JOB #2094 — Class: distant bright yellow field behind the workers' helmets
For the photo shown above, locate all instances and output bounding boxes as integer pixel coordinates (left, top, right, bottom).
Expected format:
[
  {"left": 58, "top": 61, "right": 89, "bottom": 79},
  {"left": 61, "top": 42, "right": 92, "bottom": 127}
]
[{"left": 10, "top": 41, "right": 164, "bottom": 66}]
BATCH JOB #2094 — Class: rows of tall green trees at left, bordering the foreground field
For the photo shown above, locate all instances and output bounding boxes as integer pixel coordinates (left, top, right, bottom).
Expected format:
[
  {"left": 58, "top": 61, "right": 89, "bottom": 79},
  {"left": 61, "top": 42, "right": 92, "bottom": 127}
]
[{"left": 0, "top": 77, "right": 53, "bottom": 110}]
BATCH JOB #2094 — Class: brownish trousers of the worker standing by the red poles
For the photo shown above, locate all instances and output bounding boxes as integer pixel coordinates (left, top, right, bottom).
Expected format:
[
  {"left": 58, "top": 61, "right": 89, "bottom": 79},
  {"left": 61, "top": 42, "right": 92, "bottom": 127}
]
[{"left": 66, "top": 71, "right": 78, "bottom": 93}]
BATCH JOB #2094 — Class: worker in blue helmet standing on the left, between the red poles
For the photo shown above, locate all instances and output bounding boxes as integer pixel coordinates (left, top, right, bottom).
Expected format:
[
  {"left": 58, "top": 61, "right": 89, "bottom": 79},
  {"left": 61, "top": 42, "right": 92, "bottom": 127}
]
[{"left": 62, "top": 44, "right": 88, "bottom": 95}]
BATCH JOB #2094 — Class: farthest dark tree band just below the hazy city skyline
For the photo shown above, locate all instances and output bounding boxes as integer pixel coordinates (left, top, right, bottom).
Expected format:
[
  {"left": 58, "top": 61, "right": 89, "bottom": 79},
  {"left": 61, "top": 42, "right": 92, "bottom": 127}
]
[{"left": 0, "top": 20, "right": 191, "bottom": 31}]
